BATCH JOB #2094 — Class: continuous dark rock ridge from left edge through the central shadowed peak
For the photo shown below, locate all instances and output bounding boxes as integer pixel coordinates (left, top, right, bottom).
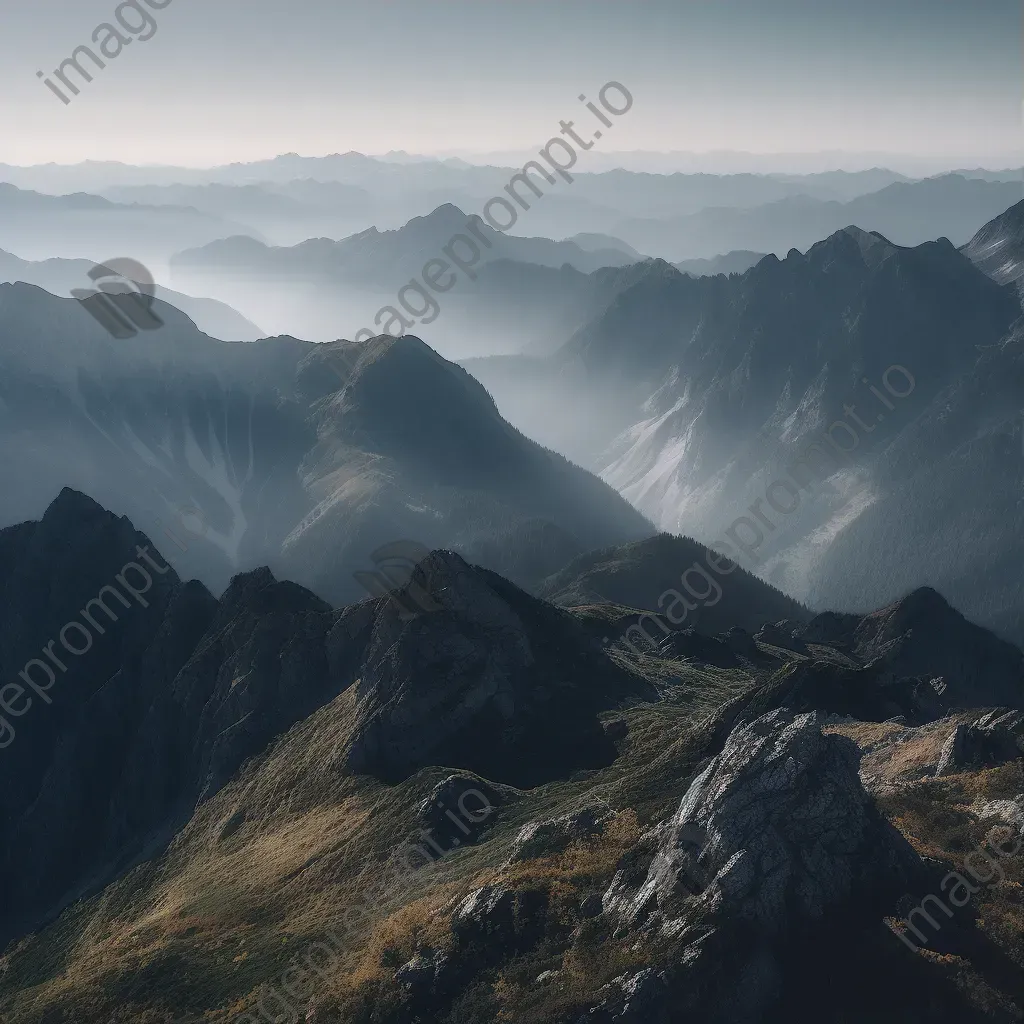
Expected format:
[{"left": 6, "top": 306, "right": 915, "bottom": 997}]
[{"left": 0, "top": 489, "right": 656, "bottom": 945}]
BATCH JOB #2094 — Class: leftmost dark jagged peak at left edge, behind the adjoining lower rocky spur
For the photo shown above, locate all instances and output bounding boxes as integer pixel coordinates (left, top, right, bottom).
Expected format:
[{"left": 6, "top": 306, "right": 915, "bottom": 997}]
[{"left": 0, "top": 488, "right": 196, "bottom": 945}]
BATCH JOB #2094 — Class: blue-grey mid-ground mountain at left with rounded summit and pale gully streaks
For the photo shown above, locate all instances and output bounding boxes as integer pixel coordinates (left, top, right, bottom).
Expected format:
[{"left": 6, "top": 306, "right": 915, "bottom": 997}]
[{"left": 0, "top": 285, "right": 653, "bottom": 602}]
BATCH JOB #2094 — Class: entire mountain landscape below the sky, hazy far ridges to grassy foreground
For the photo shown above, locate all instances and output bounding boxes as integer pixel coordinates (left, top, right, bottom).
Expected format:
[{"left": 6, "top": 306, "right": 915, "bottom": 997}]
[{"left": 0, "top": 144, "right": 1024, "bottom": 1024}]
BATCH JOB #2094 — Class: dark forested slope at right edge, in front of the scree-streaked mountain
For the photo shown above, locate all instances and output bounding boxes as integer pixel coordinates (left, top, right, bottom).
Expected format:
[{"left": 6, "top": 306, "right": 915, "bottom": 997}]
[{"left": 809, "top": 329, "right": 1024, "bottom": 641}]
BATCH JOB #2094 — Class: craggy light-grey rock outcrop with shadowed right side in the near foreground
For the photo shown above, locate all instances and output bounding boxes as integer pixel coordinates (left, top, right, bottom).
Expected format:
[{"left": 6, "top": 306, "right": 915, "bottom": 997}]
[{"left": 604, "top": 711, "right": 921, "bottom": 1024}]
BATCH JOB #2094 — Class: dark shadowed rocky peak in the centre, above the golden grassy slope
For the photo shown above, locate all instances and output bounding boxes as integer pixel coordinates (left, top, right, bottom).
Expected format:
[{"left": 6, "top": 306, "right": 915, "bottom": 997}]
[{"left": 349, "top": 552, "right": 649, "bottom": 785}]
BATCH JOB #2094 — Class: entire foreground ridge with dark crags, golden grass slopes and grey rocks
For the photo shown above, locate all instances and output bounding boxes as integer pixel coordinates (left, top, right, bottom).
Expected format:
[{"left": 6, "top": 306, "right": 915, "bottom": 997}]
[{"left": 6, "top": 492, "right": 1024, "bottom": 1024}]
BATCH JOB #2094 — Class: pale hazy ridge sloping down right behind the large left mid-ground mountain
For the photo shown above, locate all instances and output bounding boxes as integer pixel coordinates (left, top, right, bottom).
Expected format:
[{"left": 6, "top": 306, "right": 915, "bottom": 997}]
[{"left": 0, "top": 251, "right": 266, "bottom": 341}]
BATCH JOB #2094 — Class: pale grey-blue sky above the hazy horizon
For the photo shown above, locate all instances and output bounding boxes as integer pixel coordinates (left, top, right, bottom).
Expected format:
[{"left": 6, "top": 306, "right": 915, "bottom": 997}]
[{"left": 0, "top": 0, "right": 1022, "bottom": 166}]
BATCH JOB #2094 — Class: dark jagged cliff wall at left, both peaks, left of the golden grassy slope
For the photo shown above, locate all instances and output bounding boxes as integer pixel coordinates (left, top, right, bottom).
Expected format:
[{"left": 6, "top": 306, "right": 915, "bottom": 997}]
[{"left": 0, "top": 490, "right": 352, "bottom": 944}]
